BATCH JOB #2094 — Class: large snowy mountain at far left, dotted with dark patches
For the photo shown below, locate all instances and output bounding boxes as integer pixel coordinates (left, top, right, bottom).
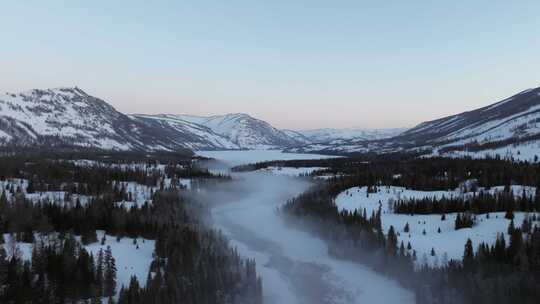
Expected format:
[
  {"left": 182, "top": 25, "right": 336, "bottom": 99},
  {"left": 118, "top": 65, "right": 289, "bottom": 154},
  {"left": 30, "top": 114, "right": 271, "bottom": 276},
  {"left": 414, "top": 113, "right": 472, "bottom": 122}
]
[{"left": 0, "top": 87, "right": 192, "bottom": 151}]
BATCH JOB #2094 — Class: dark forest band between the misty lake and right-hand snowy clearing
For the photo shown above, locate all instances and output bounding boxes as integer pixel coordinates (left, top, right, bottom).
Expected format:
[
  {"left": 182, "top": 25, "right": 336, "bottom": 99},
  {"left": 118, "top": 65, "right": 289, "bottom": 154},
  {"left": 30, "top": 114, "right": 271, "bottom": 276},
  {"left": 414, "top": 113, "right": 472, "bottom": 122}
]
[{"left": 255, "top": 155, "right": 540, "bottom": 193}]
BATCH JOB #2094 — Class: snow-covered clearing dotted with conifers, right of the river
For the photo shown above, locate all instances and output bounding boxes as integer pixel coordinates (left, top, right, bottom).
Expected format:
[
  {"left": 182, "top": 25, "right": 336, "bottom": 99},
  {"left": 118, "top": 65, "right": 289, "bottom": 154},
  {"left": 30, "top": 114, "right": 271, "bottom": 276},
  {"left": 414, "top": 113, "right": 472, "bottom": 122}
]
[{"left": 335, "top": 186, "right": 540, "bottom": 265}]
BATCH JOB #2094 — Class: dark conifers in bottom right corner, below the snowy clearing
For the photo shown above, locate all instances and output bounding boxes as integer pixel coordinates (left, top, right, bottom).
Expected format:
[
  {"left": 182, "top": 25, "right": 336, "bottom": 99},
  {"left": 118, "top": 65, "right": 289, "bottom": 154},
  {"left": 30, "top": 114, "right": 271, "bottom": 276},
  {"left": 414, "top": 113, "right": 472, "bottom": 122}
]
[{"left": 415, "top": 218, "right": 540, "bottom": 304}]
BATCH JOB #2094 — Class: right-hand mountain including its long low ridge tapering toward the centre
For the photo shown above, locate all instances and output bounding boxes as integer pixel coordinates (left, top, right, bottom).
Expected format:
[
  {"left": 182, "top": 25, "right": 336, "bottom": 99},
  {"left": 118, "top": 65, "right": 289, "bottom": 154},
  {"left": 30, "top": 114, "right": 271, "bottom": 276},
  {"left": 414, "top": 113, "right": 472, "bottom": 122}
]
[{"left": 290, "top": 88, "right": 540, "bottom": 159}]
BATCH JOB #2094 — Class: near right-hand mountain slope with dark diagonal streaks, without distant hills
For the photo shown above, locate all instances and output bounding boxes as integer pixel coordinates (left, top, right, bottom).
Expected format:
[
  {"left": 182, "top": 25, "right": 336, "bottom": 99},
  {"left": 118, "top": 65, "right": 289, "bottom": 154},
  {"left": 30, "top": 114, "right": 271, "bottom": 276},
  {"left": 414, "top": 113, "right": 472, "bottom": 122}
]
[{"left": 404, "top": 88, "right": 540, "bottom": 160}]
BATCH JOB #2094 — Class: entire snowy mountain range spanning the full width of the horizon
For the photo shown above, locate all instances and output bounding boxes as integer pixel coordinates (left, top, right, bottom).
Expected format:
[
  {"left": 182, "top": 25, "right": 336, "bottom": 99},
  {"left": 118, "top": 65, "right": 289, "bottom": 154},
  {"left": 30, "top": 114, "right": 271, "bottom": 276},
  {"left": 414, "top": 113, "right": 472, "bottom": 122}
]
[{"left": 0, "top": 87, "right": 540, "bottom": 162}]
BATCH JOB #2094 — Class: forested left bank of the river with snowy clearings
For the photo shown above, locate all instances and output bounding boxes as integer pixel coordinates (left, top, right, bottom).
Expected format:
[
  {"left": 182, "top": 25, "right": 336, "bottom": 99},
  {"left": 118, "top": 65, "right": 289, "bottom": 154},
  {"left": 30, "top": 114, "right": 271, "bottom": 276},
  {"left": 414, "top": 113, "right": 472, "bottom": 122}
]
[{"left": 0, "top": 155, "right": 262, "bottom": 303}]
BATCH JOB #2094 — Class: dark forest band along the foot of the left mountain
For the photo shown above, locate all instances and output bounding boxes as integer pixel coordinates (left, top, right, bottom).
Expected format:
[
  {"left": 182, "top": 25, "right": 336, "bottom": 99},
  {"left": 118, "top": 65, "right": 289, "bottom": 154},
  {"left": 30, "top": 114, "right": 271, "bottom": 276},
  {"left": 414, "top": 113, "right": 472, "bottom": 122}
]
[{"left": 0, "top": 156, "right": 219, "bottom": 195}]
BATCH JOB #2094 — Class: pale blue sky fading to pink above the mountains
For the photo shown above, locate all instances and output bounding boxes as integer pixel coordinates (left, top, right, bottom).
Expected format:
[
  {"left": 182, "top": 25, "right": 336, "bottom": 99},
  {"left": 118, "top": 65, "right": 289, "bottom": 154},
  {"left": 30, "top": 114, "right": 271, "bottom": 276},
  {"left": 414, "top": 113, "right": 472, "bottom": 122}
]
[{"left": 0, "top": 0, "right": 540, "bottom": 128}]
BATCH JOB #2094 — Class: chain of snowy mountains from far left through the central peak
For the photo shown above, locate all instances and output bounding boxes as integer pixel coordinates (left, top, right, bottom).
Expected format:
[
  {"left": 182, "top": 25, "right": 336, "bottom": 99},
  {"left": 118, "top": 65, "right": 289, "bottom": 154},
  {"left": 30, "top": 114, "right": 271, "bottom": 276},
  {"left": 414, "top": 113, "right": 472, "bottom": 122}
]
[{"left": 0, "top": 87, "right": 400, "bottom": 151}]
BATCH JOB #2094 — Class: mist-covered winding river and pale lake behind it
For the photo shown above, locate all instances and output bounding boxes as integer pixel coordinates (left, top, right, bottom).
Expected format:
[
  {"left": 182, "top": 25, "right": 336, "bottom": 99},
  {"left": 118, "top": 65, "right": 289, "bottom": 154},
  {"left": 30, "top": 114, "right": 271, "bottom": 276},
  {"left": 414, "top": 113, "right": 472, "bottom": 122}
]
[{"left": 199, "top": 151, "right": 414, "bottom": 304}]
